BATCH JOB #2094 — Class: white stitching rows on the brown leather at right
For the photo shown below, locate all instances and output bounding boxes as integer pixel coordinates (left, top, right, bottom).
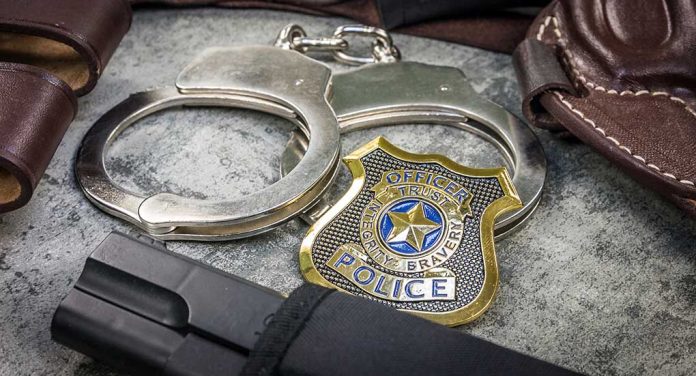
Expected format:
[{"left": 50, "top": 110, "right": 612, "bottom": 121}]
[{"left": 536, "top": 16, "right": 696, "bottom": 187}]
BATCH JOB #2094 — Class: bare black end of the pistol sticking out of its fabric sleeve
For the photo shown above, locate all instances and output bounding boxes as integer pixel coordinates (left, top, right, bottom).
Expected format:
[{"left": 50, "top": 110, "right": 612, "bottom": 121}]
[{"left": 51, "top": 232, "right": 284, "bottom": 376}]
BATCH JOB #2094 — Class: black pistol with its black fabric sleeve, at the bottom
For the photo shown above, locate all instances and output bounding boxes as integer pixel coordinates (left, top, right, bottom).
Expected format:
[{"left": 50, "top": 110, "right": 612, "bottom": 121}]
[{"left": 51, "top": 232, "right": 576, "bottom": 376}]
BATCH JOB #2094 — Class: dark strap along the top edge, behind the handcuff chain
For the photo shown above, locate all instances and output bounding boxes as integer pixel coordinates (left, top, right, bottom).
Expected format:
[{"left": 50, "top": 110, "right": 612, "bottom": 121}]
[{"left": 130, "top": 0, "right": 549, "bottom": 53}]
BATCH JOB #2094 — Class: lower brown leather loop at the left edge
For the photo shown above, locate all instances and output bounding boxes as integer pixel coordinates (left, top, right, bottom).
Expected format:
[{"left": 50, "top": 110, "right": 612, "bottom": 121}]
[{"left": 0, "top": 63, "right": 77, "bottom": 213}]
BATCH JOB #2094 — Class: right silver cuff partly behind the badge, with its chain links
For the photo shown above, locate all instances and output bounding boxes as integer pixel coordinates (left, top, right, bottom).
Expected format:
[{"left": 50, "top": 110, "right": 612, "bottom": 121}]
[{"left": 276, "top": 25, "right": 546, "bottom": 237}]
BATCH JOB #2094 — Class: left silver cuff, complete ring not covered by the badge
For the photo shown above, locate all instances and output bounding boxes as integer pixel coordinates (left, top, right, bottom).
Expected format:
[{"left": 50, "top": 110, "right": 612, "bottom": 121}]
[{"left": 76, "top": 46, "right": 340, "bottom": 240}]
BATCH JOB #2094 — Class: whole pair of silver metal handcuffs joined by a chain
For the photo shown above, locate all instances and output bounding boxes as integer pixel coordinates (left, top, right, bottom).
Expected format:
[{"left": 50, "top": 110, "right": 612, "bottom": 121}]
[{"left": 76, "top": 25, "right": 546, "bottom": 241}]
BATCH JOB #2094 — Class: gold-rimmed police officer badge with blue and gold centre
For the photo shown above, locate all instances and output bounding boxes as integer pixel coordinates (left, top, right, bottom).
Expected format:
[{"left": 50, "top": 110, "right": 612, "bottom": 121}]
[{"left": 300, "top": 137, "right": 522, "bottom": 326}]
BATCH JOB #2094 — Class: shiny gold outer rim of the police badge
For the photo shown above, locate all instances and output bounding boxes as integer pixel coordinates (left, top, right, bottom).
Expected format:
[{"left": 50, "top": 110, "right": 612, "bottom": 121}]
[{"left": 299, "top": 137, "right": 522, "bottom": 326}]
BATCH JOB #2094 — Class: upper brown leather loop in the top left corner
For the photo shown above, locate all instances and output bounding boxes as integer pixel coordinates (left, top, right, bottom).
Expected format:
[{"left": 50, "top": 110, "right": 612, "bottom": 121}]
[{"left": 0, "top": 0, "right": 132, "bottom": 95}]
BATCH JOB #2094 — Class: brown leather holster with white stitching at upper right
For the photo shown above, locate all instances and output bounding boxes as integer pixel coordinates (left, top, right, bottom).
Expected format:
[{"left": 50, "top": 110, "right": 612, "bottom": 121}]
[{"left": 514, "top": 0, "right": 696, "bottom": 216}]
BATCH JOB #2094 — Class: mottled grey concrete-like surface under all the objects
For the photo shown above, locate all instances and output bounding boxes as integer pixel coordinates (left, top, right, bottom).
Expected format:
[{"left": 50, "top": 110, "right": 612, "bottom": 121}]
[{"left": 0, "top": 9, "right": 696, "bottom": 375}]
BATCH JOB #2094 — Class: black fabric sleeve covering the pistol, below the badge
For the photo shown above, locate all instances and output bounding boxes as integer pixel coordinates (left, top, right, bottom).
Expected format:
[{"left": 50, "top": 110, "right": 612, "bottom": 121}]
[{"left": 242, "top": 284, "right": 576, "bottom": 376}]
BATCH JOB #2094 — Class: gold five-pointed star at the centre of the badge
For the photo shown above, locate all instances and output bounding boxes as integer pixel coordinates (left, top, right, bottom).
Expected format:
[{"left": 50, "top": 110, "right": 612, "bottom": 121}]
[{"left": 387, "top": 202, "right": 441, "bottom": 253}]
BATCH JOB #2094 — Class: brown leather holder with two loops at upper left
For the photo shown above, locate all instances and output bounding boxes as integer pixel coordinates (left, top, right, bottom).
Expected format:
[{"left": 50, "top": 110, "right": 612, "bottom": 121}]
[{"left": 0, "top": 0, "right": 131, "bottom": 213}]
